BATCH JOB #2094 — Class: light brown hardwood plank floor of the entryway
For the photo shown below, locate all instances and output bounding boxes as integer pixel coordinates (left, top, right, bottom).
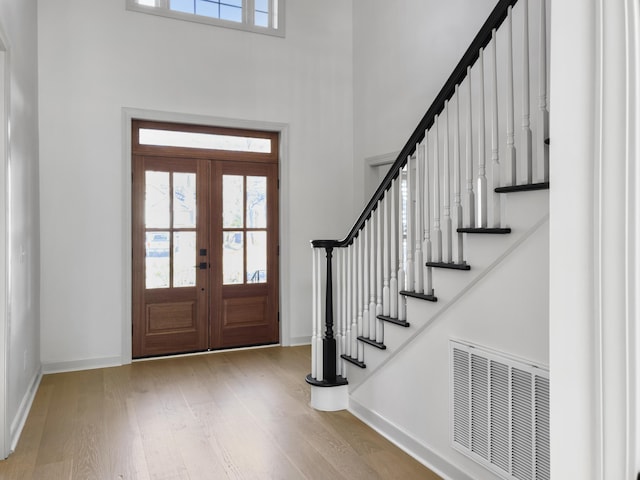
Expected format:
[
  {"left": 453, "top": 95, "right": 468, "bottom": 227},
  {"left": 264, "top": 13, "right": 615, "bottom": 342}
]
[{"left": 0, "top": 347, "right": 440, "bottom": 480}]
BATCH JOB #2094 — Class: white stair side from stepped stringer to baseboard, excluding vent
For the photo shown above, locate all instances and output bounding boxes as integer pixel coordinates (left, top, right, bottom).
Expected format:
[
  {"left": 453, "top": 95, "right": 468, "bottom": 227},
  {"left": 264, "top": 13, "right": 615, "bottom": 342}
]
[{"left": 349, "top": 200, "right": 549, "bottom": 480}]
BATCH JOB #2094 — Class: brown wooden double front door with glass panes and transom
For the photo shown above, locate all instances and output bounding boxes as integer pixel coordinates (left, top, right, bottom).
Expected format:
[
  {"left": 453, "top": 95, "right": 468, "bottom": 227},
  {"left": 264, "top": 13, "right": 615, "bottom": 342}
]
[{"left": 132, "top": 121, "right": 279, "bottom": 358}]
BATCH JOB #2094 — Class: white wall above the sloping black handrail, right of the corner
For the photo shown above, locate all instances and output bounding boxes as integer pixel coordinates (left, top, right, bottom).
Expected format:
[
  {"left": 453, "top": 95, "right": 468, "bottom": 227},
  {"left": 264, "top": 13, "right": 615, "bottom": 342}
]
[{"left": 353, "top": 0, "right": 496, "bottom": 209}]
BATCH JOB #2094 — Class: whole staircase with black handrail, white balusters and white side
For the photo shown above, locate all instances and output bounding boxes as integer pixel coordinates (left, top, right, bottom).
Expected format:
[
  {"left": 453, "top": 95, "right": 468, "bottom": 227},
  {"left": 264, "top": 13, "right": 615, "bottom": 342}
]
[{"left": 307, "top": 0, "right": 549, "bottom": 479}]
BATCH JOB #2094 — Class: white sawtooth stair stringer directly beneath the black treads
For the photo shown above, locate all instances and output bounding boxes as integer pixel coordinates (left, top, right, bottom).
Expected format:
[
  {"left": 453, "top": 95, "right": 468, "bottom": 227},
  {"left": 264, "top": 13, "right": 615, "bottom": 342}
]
[{"left": 346, "top": 190, "right": 549, "bottom": 380}]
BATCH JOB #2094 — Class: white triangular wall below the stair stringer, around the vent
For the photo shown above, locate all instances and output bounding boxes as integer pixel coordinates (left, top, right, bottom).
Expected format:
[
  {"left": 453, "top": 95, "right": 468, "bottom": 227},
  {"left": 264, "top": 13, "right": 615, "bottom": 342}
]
[{"left": 349, "top": 214, "right": 549, "bottom": 480}]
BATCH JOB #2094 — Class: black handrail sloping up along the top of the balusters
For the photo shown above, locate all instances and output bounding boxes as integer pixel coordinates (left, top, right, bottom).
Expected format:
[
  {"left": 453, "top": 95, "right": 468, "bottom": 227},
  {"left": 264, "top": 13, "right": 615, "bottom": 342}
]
[{"left": 311, "top": 0, "right": 518, "bottom": 248}]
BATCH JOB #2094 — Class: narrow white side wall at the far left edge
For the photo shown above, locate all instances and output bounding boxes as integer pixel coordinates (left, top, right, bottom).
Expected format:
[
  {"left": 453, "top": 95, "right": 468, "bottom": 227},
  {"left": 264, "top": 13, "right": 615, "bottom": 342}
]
[{"left": 0, "top": 0, "right": 40, "bottom": 453}]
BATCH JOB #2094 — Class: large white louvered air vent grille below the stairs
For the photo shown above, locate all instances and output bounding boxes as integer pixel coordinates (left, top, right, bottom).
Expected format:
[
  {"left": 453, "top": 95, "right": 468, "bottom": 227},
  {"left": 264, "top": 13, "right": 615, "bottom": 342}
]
[{"left": 451, "top": 341, "right": 550, "bottom": 480}]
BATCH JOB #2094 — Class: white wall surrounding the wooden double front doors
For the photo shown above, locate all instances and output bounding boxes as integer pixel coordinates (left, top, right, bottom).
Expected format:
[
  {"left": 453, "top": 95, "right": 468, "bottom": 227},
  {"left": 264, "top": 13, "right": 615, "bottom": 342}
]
[{"left": 38, "top": 0, "right": 354, "bottom": 364}]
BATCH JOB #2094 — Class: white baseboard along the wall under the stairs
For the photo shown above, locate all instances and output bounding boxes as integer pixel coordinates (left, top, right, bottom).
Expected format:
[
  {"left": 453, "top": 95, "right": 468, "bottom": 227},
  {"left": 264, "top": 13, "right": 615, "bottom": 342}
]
[{"left": 349, "top": 397, "right": 474, "bottom": 480}]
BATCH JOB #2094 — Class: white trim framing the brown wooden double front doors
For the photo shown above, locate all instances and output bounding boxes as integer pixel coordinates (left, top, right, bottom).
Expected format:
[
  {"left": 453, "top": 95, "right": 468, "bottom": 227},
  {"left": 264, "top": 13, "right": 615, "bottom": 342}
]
[{"left": 121, "top": 108, "right": 291, "bottom": 364}]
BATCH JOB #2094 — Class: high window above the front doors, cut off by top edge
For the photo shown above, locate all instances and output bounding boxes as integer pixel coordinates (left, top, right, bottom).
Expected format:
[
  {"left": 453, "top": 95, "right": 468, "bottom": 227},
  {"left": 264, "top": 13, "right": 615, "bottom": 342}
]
[{"left": 126, "top": 0, "right": 284, "bottom": 36}]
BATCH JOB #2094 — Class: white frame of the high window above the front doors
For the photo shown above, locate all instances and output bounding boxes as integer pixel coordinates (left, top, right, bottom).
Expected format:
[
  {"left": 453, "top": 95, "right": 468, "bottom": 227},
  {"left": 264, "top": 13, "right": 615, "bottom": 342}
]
[{"left": 126, "top": 0, "right": 285, "bottom": 37}]
